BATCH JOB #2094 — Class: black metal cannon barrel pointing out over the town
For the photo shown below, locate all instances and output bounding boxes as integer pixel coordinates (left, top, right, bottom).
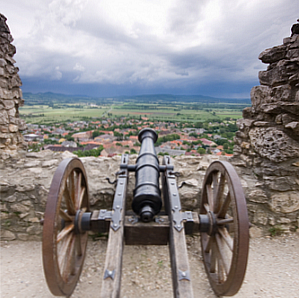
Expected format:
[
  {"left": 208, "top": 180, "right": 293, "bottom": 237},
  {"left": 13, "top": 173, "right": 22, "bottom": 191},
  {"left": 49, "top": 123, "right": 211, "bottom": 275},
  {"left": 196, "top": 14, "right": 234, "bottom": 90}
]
[{"left": 132, "top": 128, "right": 162, "bottom": 222}]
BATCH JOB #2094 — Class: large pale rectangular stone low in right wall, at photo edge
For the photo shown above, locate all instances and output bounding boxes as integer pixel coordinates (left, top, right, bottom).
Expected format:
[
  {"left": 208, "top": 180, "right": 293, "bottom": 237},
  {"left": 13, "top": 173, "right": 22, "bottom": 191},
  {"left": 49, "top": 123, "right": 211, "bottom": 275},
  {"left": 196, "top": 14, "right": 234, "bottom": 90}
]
[{"left": 269, "top": 192, "right": 299, "bottom": 213}]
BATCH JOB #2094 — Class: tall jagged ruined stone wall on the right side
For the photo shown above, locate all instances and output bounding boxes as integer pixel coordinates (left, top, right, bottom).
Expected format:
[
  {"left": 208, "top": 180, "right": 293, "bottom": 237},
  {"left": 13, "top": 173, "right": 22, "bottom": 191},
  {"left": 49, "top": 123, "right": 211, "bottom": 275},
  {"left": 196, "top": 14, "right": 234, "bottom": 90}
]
[{"left": 233, "top": 20, "right": 299, "bottom": 235}]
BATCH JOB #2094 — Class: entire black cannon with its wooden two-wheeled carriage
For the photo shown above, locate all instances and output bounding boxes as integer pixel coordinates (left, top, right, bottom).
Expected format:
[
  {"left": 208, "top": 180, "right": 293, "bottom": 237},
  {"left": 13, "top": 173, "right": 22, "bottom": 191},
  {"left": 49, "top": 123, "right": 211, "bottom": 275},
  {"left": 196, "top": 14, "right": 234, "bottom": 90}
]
[{"left": 42, "top": 128, "right": 249, "bottom": 298}]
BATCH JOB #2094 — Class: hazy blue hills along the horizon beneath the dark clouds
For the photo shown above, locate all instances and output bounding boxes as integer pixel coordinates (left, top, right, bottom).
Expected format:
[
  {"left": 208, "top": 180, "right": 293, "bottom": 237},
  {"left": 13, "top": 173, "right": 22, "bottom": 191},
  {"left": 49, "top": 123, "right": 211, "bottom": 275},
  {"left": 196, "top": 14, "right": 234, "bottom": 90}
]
[{"left": 23, "top": 92, "right": 251, "bottom": 105}]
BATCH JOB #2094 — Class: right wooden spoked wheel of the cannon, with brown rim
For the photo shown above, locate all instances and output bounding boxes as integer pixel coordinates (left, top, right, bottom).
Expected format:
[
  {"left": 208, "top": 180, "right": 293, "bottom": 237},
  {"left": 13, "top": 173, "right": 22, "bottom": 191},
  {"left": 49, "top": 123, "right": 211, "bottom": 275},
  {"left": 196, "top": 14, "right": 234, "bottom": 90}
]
[{"left": 200, "top": 161, "right": 249, "bottom": 296}]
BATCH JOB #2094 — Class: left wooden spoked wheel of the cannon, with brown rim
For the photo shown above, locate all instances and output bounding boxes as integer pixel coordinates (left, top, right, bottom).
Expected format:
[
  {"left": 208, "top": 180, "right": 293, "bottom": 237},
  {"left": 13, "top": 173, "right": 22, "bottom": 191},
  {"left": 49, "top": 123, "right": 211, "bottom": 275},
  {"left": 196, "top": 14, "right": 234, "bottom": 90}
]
[{"left": 42, "top": 158, "right": 89, "bottom": 296}]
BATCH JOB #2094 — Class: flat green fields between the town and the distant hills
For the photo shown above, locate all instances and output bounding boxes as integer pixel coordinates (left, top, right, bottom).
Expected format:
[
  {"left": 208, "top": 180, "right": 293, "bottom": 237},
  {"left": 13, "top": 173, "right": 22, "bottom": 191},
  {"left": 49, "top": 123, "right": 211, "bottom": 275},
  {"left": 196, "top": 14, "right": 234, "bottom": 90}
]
[{"left": 20, "top": 103, "right": 244, "bottom": 124}]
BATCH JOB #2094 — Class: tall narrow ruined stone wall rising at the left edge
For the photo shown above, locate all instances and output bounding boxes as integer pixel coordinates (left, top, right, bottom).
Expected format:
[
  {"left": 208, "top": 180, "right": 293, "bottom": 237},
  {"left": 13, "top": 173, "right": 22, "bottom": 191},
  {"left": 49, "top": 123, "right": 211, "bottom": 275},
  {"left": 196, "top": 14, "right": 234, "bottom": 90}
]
[{"left": 0, "top": 14, "right": 26, "bottom": 159}]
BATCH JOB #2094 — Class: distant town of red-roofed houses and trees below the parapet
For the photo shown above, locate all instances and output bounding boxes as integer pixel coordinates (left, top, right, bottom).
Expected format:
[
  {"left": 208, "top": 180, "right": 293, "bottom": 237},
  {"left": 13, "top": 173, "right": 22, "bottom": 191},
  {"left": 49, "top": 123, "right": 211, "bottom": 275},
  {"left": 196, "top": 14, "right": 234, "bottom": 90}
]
[{"left": 24, "top": 116, "right": 238, "bottom": 157}]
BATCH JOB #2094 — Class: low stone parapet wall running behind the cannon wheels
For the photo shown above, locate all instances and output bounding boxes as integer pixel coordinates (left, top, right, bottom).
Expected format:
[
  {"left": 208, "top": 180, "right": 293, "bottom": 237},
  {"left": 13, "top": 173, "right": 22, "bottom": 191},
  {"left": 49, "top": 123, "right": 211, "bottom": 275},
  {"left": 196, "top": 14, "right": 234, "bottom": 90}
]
[{"left": 0, "top": 150, "right": 234, "bottom": 240}]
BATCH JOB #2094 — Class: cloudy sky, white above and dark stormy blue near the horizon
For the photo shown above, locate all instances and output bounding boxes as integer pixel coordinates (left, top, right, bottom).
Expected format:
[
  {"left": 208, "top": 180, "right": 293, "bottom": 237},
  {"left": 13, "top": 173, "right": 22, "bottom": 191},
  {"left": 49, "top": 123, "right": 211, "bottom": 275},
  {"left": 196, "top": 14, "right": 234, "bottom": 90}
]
[{"left": 0, "top": 0, "right": 299, "bottom": 98}]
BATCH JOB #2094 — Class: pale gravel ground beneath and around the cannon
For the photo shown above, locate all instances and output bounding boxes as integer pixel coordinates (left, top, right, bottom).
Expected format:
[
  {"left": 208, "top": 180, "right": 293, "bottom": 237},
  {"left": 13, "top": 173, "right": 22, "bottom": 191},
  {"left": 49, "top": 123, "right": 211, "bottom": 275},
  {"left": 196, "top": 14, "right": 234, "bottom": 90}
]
[{"left": 0, "top": 233, "right": 299, "bottom": 298}]
